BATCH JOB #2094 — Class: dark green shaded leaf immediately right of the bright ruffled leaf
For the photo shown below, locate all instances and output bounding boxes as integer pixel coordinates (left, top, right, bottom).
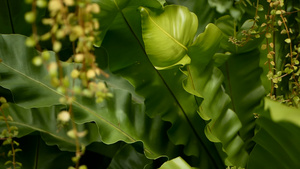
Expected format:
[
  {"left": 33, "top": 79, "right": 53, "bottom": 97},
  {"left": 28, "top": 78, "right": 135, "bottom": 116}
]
[{"left": 222, "top": 49, "right": 265, "bottom": 151}]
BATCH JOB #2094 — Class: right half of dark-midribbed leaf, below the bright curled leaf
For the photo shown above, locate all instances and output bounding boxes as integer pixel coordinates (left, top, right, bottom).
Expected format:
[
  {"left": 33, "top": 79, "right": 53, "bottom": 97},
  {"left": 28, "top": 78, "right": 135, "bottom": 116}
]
[{"left": 160, "top": 67, "right": 223, "bottom": 168}]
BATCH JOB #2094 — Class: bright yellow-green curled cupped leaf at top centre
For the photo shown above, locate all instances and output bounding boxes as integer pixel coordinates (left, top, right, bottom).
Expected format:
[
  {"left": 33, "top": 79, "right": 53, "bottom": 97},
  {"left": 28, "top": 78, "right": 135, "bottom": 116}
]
[{"left": 140, "top": 5, "right": 198, "bottom": 68}]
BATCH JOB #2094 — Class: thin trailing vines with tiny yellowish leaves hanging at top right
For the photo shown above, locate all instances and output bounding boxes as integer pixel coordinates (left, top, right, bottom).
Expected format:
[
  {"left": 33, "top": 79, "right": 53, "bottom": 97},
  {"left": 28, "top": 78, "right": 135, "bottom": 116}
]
[{"left": 229, "top": 0, "right": 300, "bottom": 107}]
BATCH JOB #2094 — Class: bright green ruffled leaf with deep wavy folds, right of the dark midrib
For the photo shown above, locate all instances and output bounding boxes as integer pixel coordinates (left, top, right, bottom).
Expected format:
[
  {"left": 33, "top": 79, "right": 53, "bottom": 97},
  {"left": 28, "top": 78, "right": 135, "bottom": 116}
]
[{"left": 185, "top": 24, "right": 248, "bottom": 166}]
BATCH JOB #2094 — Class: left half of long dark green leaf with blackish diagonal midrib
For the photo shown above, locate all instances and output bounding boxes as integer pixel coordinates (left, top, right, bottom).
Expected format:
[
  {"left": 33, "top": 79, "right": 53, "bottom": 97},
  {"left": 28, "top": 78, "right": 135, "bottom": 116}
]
[{"left": 102, "top": 2, "right": 224, "bottom": 168}]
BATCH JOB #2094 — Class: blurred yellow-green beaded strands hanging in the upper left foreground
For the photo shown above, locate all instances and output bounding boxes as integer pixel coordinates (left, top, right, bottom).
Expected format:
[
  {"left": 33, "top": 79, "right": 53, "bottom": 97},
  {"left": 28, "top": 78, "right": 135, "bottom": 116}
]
[{"left": 8, "top": 0, "right": 112, "bottom": 169}]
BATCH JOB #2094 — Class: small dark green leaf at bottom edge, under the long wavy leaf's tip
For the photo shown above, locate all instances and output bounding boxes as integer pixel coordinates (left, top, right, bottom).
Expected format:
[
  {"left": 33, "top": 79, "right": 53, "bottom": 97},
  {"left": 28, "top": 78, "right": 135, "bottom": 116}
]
[{"left": 108, "top": 145, "right": 150, "bottom": 169}]
